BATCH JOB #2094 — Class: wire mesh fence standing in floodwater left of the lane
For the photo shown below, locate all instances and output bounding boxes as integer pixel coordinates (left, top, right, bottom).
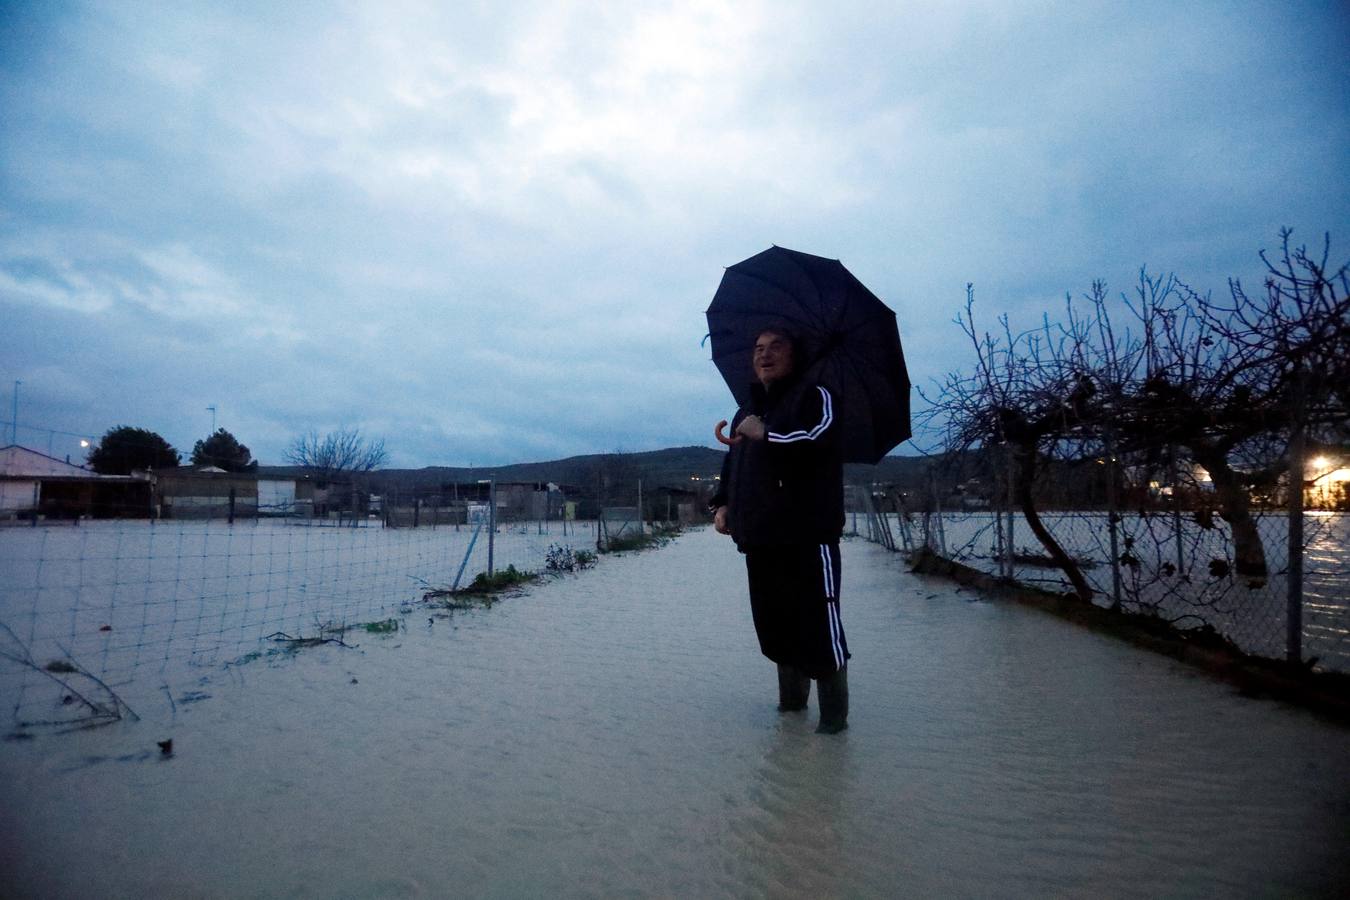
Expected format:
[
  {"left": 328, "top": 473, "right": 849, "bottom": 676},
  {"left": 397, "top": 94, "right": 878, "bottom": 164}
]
[{"left": 0, "top": 498, "right": 610, "bottom": 726}]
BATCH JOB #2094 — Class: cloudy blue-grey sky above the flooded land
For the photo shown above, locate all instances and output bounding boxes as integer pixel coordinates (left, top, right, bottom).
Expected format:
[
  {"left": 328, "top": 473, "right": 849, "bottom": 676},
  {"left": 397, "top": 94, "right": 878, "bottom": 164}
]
[{"left": 0, "top": 0, "right": 1350, "bottom": 467}]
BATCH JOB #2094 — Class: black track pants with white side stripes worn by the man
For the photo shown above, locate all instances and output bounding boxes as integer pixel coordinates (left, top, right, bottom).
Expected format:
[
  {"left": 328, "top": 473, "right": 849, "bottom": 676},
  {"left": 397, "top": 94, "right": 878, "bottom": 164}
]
[{"left": 745, "top": 544, "right": 849, "bottom": 679}]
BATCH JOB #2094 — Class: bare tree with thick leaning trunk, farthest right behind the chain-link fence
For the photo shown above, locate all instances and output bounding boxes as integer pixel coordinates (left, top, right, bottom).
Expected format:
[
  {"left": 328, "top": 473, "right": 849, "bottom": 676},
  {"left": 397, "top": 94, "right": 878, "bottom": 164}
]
[{"left": 1119, "top": 229, "right": 1350, "bottom": 578}]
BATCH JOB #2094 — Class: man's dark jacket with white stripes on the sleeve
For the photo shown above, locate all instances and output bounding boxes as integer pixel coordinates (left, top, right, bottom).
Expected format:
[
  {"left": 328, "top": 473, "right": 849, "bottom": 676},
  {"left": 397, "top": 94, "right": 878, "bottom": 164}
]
[{"left": 710, "top": 379, "right": 844, "bottom": 551}]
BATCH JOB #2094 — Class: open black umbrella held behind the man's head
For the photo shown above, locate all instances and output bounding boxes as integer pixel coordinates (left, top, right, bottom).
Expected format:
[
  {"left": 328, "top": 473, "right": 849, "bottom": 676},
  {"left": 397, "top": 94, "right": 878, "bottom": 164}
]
[{"left": 707, "top": 247, "right": 910, "bottom": 464}]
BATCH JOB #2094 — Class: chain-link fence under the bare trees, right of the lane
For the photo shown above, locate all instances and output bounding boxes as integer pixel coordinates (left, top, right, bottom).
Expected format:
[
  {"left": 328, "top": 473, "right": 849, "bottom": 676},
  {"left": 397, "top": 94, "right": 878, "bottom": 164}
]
[{"left": 852, "top": 477, "right": 1350, "bottom": 672}]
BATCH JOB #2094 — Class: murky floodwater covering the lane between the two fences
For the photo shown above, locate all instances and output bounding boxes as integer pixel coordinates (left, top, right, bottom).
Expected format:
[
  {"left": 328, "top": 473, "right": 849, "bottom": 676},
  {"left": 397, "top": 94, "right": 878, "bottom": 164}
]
[{"left": 0, "top": 530, "right": 1350, "bottom": 897}]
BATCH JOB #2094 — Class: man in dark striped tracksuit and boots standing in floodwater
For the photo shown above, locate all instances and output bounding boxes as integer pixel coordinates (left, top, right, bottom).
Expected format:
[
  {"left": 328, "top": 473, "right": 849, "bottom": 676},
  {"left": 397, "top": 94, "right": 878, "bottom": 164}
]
[{"left": 709, "top": 328, "right": 849, "bottom": 734}]
